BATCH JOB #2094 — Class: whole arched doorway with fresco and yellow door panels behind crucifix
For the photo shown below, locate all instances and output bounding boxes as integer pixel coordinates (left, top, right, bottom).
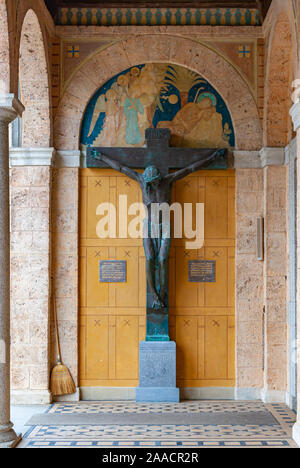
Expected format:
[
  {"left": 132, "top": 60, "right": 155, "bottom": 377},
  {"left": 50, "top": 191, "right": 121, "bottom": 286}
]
[{"left": 79, "top": 63, "right": 235, "bottom": 399}]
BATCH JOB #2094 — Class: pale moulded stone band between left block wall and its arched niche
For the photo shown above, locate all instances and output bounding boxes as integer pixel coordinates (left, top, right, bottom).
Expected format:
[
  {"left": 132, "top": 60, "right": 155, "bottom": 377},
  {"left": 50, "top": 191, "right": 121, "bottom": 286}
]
[{"left": 9, "top": 148, "right": 55, "bottom": 167}]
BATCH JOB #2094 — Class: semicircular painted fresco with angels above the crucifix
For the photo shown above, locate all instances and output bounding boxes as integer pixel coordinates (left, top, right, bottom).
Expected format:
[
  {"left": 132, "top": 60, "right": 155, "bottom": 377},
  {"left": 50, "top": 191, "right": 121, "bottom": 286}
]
[{"left": 83, "top": 63, "right": 233, "bottom": 148}]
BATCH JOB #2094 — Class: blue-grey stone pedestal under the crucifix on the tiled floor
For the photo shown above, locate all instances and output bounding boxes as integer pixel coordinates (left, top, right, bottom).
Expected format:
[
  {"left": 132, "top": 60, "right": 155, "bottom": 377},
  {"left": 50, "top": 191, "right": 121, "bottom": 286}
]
[{"left": 136, "top": 341, "right": 179, "bottom": 403}]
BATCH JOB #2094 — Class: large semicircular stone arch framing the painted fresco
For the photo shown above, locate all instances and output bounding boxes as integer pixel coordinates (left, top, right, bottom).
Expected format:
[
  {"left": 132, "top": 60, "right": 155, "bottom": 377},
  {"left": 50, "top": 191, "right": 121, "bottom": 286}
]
[{"left": 54, "top": 34, "right": 262, "bottom": 150}]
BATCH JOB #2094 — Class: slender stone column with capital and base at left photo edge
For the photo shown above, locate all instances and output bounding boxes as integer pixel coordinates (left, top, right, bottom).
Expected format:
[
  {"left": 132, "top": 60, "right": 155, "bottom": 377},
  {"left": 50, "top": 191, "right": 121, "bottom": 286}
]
[{"left": 0, "top": 94, "right": 24, "bottom": 448}]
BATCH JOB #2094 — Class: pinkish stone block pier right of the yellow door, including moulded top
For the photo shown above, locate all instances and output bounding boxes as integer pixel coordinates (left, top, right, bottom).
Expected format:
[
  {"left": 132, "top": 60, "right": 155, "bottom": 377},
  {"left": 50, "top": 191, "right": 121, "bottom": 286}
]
[{"left": 234, "top": 148, "right": 287, "bottom": 402}]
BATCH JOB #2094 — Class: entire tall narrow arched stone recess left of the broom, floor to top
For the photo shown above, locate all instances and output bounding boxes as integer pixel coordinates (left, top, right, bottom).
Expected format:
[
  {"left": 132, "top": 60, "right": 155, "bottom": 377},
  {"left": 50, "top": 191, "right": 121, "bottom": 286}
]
[{"left": 10, "top": 4, "right": 53, "bottom": 403}]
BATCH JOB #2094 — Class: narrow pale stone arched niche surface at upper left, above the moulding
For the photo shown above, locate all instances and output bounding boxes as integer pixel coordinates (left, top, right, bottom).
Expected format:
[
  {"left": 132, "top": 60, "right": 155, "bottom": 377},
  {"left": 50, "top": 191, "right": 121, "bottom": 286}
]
[{"left": 19, "top": 9, "right": 51, "bottom": 147}]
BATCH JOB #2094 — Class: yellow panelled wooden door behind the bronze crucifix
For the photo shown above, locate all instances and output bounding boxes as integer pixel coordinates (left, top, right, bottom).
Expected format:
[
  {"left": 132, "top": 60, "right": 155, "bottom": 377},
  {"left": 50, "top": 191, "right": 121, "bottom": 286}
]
[{"left": 80, "top": 169, "right": 235, "bottom": 387}]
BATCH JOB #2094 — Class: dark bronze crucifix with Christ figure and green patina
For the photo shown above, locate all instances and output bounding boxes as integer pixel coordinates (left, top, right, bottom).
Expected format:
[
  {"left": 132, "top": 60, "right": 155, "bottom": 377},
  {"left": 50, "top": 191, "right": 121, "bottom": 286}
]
[{"left": 87, "top": 128, "right": 228, "bottom": 341}]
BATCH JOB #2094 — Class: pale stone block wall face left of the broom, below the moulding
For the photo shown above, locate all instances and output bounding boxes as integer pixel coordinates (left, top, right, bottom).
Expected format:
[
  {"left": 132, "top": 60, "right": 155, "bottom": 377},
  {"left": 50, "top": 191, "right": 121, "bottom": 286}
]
[{"left": 11, "top": 167, "right": 51, "bottom": 403}]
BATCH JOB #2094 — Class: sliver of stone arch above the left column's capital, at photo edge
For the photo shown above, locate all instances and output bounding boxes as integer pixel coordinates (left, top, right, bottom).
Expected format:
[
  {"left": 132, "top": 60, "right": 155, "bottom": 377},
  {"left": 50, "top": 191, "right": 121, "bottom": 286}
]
[{"left": 0, "top": 0, "right": 10, "bottom": 94}]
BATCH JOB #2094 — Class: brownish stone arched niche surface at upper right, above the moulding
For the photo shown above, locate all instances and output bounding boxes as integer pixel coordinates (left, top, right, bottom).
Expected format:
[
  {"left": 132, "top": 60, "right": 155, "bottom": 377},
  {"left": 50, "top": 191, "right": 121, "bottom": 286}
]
[{"left": 263, "top": 4, "right": 297, "bottom": 147}]
